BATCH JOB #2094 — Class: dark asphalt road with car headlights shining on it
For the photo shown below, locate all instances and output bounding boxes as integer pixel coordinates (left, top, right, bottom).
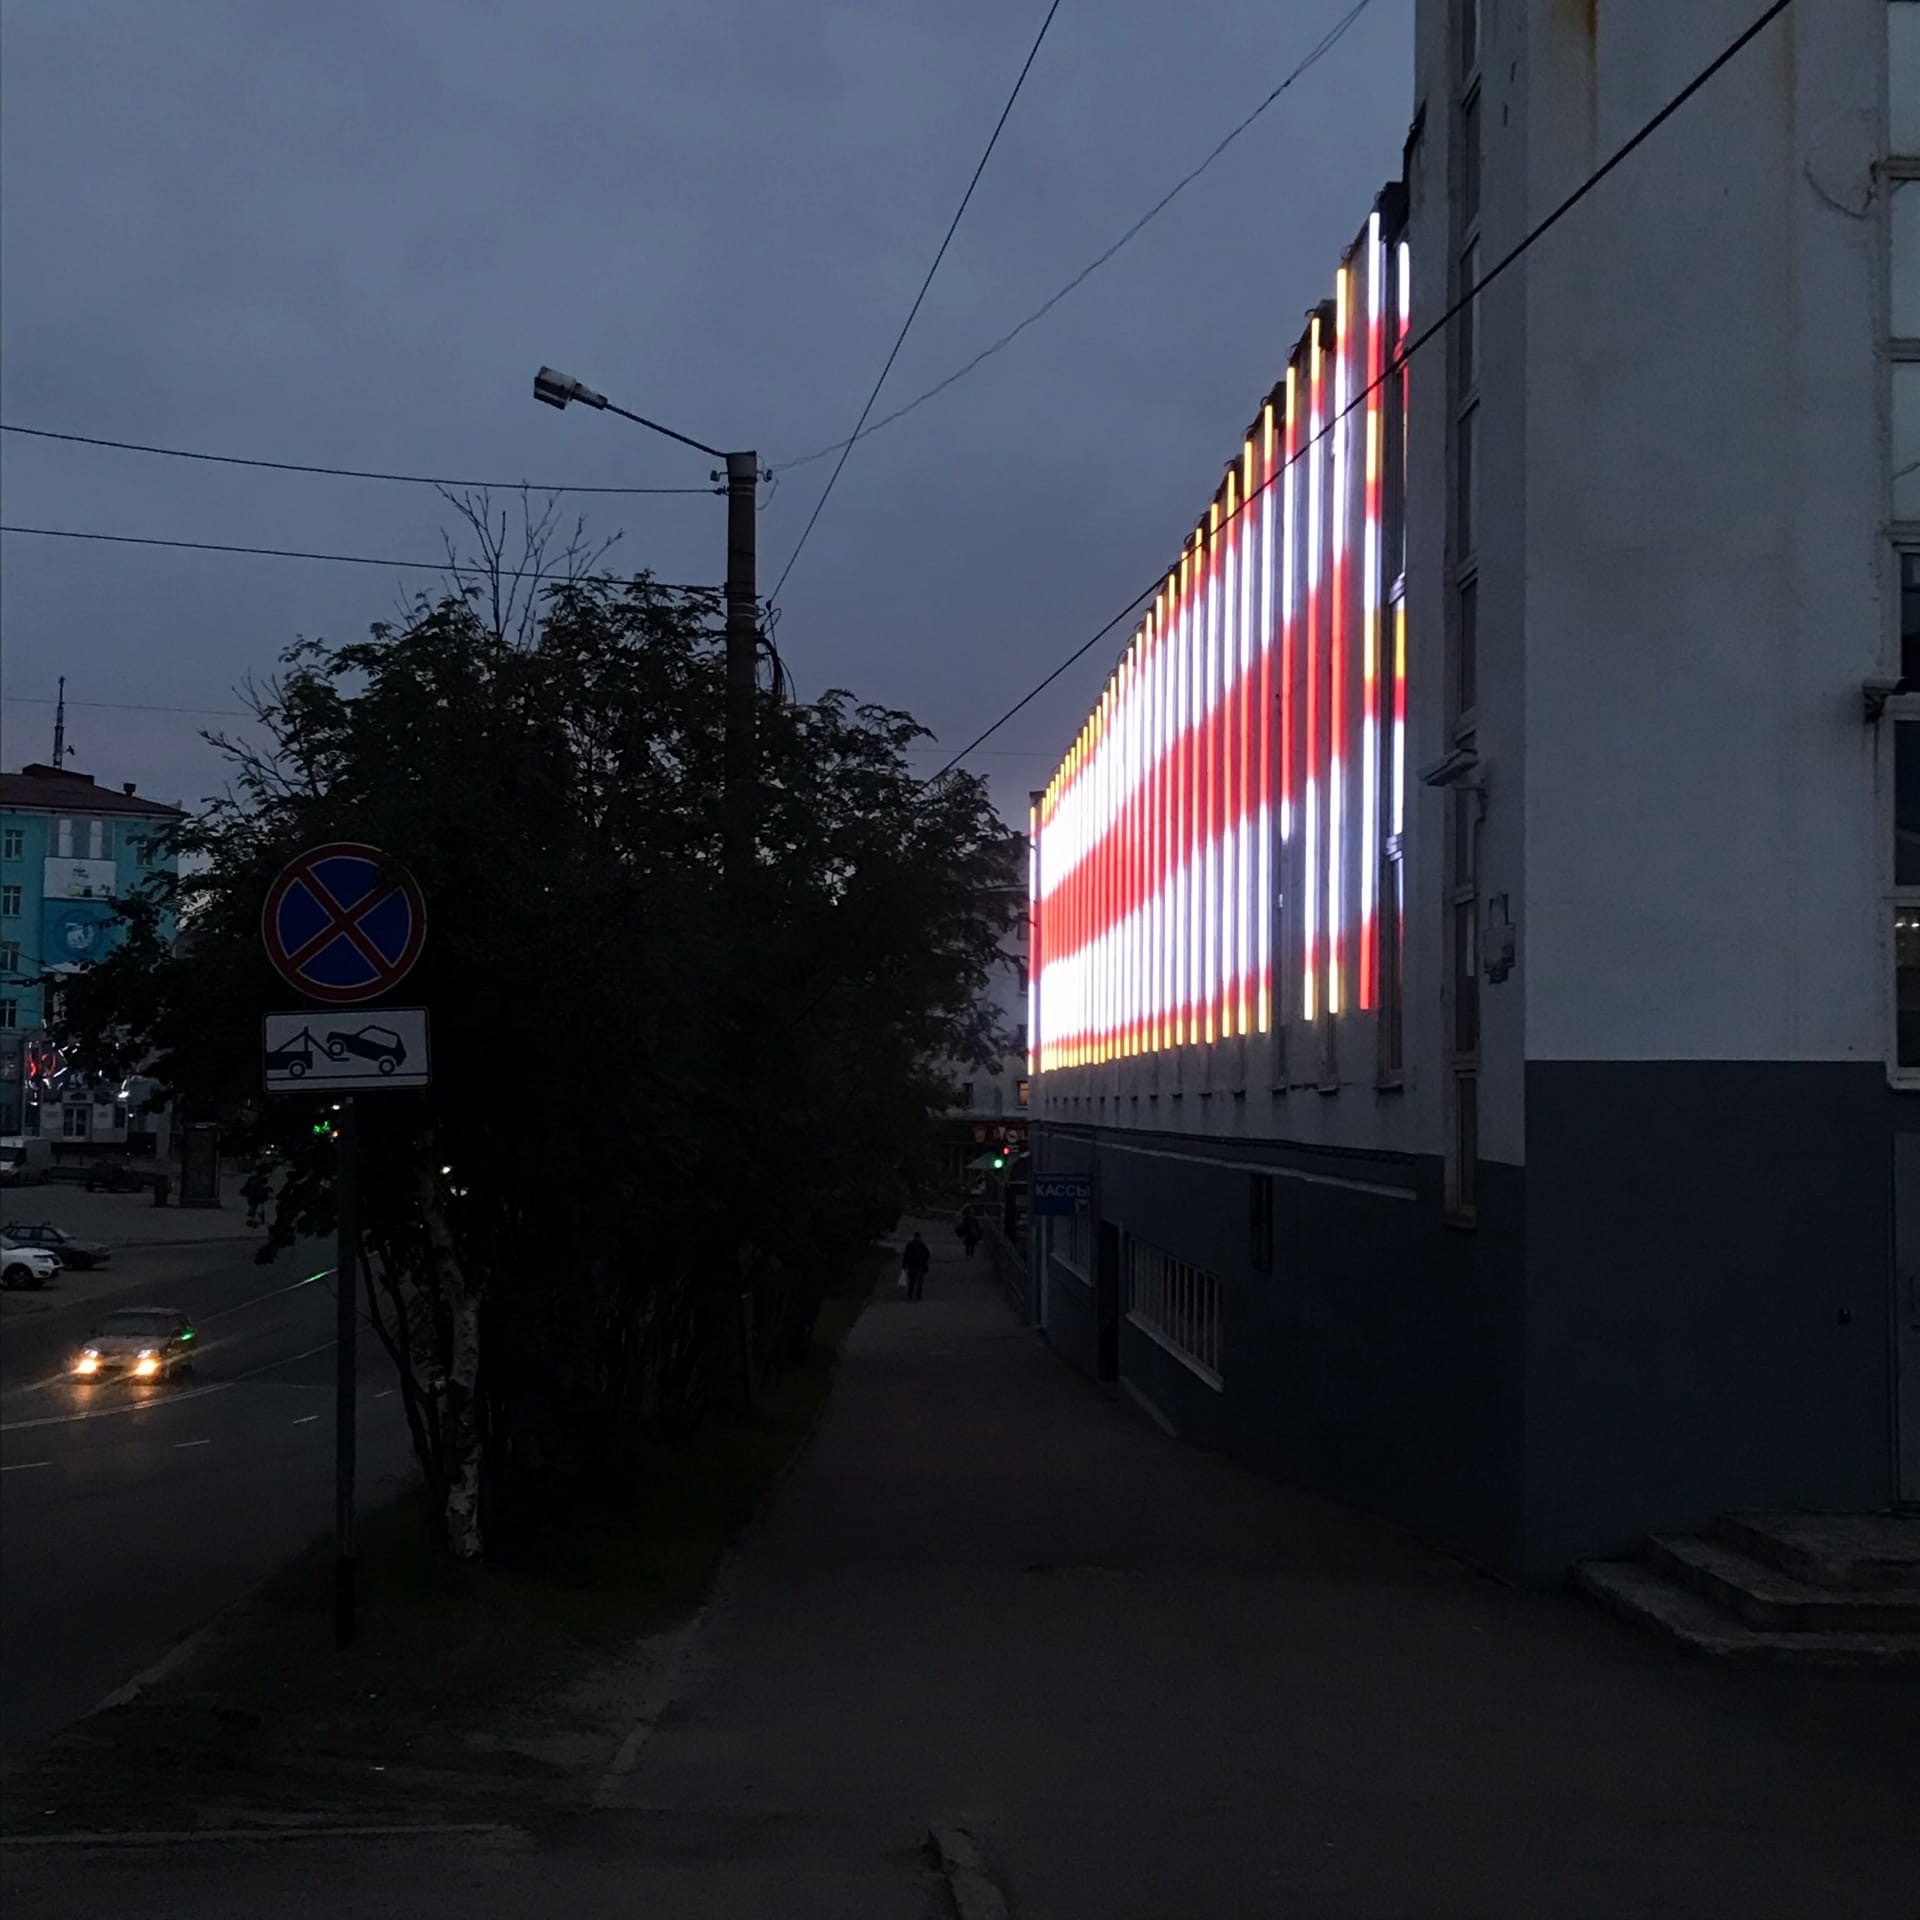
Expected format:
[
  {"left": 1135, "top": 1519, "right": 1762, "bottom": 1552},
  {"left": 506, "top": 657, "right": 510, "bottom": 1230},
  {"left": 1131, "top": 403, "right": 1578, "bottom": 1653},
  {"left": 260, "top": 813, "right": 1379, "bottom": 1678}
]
[{"left": 0, "top": 1244, "right": 407, "bottom": 1772}]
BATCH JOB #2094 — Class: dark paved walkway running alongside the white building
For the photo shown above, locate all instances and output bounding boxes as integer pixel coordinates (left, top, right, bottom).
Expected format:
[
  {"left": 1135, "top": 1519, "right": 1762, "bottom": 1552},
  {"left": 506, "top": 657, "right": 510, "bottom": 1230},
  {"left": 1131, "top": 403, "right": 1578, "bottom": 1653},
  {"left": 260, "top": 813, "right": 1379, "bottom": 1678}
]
[{"left": 10, "top": 1233, "right": 1920, "bottom": 1920}]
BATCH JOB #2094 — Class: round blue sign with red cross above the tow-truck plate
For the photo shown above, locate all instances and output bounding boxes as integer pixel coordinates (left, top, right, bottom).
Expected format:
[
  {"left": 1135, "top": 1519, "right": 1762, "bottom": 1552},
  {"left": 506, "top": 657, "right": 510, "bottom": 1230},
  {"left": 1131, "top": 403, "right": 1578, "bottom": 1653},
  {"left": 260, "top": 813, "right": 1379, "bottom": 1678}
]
[{"left": 259, "top": 841, "right": 426, "bottom": 1006}]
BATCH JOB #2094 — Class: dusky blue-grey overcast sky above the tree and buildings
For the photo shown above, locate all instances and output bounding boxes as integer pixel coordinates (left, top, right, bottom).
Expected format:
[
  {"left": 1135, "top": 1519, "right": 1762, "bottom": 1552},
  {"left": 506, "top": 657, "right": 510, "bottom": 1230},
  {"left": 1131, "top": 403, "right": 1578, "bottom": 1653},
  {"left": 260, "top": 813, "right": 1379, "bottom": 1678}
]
[{"left": 0, "top": 0, "right": 1413, "bottom": 824}]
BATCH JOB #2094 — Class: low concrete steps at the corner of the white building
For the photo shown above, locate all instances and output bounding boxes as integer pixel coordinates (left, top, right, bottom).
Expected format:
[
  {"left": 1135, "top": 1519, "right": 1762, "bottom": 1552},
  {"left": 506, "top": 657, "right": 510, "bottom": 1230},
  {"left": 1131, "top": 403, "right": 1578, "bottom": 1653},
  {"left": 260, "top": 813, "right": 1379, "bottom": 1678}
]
[{"left": 1574, "top": 1513, "right": 1920, "bottom": 1672}]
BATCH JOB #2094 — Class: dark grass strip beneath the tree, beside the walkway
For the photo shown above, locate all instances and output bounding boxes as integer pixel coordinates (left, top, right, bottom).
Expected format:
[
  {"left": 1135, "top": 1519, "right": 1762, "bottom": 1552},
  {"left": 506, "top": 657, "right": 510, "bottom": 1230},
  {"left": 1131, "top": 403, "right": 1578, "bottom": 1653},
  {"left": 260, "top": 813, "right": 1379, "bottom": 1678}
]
[{"left": 194, "top": 1256, "right": 891, "bottom": 1718}]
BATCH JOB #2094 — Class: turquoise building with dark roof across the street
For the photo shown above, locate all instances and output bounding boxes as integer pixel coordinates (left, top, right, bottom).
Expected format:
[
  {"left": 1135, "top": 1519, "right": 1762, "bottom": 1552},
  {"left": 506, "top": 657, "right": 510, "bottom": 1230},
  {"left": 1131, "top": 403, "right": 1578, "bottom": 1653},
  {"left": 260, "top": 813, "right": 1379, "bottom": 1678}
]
[{"left": 0, "top": 764, "right": 180, "bottom": 1144}]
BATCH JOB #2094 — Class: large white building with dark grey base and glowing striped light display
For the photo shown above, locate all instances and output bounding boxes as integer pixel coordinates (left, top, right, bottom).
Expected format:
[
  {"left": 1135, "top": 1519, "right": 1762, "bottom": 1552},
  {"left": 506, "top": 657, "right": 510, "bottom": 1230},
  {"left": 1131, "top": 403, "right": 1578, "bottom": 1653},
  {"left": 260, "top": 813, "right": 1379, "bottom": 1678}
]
[{"left": 1029, "top": 0, "right": 1920, "bottom": 1578}]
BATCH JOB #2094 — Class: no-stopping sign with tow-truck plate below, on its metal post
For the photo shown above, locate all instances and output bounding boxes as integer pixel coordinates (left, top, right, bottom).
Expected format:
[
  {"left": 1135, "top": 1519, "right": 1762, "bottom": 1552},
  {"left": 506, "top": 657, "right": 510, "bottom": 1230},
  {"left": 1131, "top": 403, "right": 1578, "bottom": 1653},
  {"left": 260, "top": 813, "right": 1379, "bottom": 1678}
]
[{"left": 261, "top": 841, "right": 428, "bottom": 1647}]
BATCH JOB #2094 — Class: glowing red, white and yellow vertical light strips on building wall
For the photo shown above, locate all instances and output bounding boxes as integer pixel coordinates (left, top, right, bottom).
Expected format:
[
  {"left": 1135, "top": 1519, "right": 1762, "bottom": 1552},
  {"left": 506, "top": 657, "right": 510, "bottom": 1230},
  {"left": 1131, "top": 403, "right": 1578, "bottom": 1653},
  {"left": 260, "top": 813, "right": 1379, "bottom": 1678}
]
[{"left": 1027, "top": 186, "right": 1409, "bottom": 1071}]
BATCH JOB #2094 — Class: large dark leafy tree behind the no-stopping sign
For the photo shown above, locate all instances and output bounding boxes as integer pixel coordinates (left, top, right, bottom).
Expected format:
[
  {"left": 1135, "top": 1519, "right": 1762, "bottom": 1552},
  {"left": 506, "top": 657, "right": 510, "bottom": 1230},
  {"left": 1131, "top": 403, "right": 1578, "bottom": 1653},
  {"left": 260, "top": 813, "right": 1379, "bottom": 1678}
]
[{"left": 65, "top": 503, "right": 1020, "bottom": 1555}]
